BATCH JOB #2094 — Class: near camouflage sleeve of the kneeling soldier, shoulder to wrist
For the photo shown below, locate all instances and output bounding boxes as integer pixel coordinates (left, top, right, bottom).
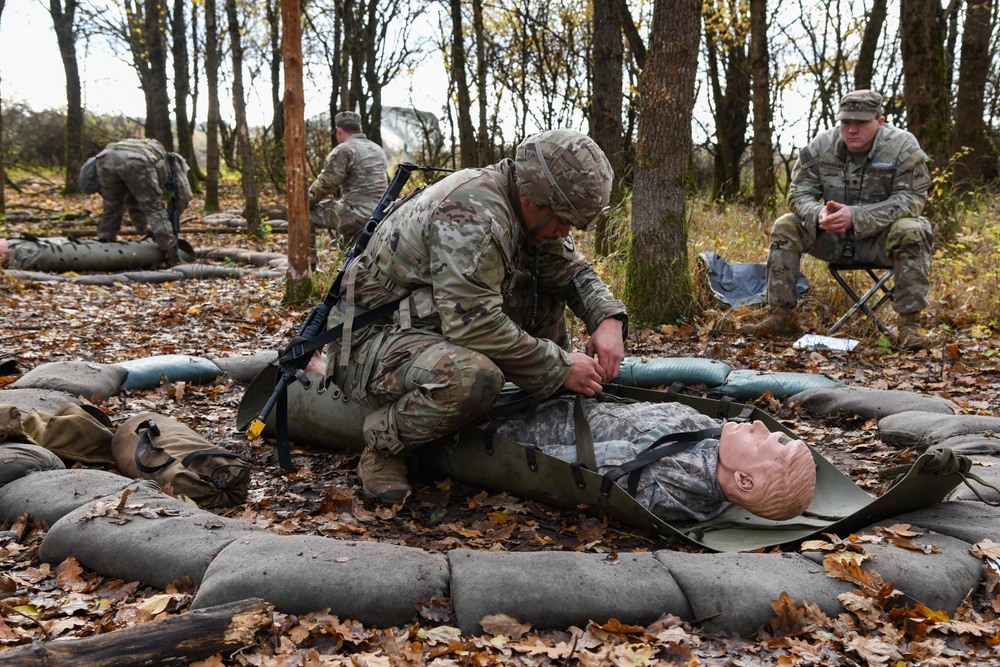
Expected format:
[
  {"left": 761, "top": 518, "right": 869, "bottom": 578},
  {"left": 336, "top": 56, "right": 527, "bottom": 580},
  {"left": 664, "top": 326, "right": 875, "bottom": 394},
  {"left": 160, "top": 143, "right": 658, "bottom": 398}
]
[{"left": 428, "top": 215, "right": 572, "bottom": 396}]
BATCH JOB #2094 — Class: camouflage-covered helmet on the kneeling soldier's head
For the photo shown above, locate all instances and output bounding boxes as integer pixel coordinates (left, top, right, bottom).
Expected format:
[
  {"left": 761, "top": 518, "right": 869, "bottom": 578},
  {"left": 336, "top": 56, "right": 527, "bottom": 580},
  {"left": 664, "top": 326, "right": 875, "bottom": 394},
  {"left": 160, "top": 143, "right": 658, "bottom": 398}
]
[{"left": 514, "top": 130, "right": 614, "bottom": 230}]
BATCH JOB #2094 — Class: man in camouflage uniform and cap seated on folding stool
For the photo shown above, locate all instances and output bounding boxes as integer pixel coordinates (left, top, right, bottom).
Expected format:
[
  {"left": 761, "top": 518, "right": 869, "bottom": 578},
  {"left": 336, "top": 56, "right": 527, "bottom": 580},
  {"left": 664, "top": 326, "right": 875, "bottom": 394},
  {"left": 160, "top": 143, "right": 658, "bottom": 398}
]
[{"left": 743, "top": 90, "right": 933, "bottom": 349}]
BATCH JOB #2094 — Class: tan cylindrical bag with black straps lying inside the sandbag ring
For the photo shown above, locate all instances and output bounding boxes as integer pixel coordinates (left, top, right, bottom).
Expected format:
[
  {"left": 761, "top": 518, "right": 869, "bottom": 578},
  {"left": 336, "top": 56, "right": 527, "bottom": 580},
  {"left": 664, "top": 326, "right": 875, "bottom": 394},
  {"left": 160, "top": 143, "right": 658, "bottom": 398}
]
[{"left": 111, "top": 412, "right": 250, "bottom": 507}]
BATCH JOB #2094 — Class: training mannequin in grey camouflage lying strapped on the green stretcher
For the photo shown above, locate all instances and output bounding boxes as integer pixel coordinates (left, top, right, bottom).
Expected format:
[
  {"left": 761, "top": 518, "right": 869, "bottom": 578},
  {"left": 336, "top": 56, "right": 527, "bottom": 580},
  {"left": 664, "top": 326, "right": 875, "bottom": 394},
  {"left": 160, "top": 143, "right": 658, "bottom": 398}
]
[{"left": 491, "top": 398, "right": 816, "bottom": 522}]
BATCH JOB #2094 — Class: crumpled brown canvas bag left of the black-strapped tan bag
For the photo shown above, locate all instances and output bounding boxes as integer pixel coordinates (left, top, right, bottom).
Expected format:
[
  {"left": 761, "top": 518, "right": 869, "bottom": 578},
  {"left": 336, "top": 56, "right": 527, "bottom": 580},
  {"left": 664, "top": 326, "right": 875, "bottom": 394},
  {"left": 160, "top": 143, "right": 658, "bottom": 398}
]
[{"left": 24, "top": 404, "right": 115, "bottom": 466}]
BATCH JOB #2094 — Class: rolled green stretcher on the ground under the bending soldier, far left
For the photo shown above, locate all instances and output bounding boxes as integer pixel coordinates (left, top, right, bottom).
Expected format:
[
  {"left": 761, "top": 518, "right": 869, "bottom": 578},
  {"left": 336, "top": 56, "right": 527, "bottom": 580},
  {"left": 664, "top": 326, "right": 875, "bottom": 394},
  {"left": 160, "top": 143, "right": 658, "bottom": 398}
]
[{"left": 7, "top": 236, "right": 196, "bottom": 273}]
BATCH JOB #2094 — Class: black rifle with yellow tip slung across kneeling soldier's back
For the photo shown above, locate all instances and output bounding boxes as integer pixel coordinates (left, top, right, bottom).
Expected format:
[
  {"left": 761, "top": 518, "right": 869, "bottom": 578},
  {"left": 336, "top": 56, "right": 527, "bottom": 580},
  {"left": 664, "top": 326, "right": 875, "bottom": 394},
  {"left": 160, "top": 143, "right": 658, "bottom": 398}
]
[{"left": 246, "top": 162, "right": 452, "bottom": 470}]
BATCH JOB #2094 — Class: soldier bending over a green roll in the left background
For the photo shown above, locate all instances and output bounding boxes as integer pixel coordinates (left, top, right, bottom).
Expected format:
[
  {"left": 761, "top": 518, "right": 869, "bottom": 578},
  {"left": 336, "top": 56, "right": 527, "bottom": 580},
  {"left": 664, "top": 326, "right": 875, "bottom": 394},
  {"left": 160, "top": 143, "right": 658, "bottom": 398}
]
[{"left": 96, "top": 139, "right": 191, "bottom": 266}]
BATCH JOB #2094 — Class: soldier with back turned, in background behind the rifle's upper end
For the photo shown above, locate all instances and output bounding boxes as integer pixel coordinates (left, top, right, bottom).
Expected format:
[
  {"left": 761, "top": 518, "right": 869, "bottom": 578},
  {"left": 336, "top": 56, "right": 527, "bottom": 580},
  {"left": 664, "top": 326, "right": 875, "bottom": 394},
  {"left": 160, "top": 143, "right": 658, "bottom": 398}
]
[{"left": 309, "top": 111, "right": 389, "bottom": 242}]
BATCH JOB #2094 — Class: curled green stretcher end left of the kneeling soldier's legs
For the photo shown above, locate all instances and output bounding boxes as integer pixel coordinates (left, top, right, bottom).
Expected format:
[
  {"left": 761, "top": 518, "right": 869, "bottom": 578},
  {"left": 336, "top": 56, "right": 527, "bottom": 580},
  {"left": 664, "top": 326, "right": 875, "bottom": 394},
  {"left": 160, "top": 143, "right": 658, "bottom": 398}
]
[{"left": 236, "top": 365, "right": 371, "bottom": 451}]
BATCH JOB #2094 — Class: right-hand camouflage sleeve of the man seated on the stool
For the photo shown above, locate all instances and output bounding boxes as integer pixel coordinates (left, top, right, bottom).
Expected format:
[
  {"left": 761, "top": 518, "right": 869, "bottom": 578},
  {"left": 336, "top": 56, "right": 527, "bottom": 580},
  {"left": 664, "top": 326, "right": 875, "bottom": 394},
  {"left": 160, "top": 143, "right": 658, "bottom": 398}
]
[{"left": 851, "top": 143, "right": 931, "bottom": 238}]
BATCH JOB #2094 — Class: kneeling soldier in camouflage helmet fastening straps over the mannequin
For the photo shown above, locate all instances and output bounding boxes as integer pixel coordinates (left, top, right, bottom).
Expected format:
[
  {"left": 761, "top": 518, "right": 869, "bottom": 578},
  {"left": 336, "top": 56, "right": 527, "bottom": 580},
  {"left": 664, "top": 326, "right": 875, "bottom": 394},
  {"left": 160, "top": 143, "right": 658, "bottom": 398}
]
[{"left": 327, "top": 130, "right": 628, "bottom": 502}]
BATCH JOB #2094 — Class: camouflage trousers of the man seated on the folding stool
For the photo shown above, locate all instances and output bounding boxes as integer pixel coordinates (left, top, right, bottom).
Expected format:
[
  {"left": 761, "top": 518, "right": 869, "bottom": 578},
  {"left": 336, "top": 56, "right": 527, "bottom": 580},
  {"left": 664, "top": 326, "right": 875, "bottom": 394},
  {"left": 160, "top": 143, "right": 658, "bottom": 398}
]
[{"left": 767, "top": 213, "right": 934, "bottom": 314}]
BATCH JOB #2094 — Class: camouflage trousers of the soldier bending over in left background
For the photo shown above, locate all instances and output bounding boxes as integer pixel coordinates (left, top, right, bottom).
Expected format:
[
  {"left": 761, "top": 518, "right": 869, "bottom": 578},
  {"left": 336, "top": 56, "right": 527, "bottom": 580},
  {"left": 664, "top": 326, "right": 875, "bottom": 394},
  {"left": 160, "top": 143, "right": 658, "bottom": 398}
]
[{"left": 97, "top": 151, "right": 177, "bottom": 256}]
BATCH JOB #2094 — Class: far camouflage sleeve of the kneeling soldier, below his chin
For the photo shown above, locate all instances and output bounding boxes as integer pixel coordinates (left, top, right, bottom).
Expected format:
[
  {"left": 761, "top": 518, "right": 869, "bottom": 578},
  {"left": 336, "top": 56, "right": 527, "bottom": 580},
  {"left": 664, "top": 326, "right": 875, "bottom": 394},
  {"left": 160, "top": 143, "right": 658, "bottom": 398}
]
[{"left": 538, "top": 236, "right": 628, "bottom": 337}]
